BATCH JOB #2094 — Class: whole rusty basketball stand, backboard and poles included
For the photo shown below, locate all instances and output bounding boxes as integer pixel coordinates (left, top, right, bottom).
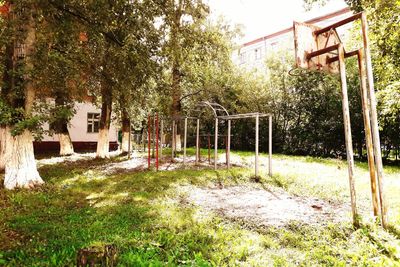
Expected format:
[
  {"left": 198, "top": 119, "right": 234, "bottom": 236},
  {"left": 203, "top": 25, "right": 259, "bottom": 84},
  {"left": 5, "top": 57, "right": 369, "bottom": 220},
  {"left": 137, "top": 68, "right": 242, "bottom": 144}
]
[{"left": 293, "top": 13, "right": 388, "bottom": 228}]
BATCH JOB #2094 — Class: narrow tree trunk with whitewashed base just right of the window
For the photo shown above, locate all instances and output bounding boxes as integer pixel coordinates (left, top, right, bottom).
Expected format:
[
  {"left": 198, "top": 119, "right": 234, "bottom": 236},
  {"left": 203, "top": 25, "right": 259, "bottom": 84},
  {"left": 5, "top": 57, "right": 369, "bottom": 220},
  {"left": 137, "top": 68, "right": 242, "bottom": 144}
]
[{"left": 97, "top": 82, "right": 112, "bottom": 159}]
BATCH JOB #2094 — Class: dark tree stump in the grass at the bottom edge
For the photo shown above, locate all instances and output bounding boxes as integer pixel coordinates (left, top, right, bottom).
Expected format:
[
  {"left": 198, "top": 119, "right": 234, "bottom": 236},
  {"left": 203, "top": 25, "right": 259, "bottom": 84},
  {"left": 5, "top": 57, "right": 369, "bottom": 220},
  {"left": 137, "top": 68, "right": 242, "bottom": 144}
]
[{"left": 76, "top": 245, "right": 117, "bottom": 267}]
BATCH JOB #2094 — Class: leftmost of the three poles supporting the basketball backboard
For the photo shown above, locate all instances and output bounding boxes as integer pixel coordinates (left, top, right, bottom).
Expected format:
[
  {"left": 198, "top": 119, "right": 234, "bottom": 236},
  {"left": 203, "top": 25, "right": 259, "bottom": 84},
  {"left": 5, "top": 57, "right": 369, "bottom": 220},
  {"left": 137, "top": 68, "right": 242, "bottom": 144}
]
[{"left": 338, "top": 44, "right": 359, "bottom": 227}]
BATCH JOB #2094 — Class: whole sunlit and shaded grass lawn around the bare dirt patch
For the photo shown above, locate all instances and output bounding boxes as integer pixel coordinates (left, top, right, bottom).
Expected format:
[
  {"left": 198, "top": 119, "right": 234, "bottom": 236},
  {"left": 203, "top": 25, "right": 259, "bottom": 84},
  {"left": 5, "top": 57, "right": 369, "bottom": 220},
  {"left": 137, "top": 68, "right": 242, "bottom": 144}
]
[{"left": 0, "top": 150, "right": 400, "bottom": 266}]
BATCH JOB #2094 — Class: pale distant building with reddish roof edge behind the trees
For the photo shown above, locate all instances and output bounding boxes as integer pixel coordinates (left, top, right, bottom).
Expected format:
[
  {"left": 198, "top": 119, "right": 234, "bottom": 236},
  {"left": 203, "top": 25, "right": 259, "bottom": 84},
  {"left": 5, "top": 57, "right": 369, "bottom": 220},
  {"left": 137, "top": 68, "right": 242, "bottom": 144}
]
[{"left": 233, "top": 8, "right": 353, "bottom": 71}]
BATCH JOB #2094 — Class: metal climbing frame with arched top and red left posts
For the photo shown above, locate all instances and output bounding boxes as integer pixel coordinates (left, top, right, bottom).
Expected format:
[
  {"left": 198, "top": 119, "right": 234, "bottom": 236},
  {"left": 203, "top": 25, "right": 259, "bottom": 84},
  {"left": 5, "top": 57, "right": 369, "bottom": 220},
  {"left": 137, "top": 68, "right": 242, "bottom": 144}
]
[{"left": 143, "top": 101, "right": 272, "bottom": 179}]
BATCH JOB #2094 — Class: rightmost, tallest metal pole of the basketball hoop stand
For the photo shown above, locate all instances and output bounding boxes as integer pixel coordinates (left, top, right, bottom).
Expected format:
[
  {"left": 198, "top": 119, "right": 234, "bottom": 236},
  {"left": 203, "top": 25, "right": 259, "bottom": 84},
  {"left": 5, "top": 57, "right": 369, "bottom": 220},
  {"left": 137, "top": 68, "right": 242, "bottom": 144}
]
[{"left": 361, "top": 13, "right": 388, "bottom": 228}]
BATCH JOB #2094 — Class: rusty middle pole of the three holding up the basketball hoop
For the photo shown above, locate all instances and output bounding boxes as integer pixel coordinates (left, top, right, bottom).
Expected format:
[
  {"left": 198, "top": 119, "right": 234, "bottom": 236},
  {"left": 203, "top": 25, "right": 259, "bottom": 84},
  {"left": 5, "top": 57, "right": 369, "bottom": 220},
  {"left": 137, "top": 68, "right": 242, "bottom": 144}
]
[{"left": 358, "top": 49, "right": 379, "bottom": 216}]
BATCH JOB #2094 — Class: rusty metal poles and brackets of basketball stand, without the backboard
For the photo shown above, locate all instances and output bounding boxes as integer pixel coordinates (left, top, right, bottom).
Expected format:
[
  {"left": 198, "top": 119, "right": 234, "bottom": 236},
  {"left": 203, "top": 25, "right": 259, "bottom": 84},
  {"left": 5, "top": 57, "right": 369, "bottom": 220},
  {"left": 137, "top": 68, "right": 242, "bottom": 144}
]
[{"left": 300, "top": 12, "right": 388, "bottom": 228}]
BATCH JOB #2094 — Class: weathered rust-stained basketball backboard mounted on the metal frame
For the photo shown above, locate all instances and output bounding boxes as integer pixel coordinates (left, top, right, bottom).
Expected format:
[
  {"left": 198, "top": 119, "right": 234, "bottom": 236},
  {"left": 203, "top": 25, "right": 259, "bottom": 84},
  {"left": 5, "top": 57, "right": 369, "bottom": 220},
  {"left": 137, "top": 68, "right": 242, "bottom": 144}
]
[{"left": 293, "top": 22, "right": 340, "bottom": 74}]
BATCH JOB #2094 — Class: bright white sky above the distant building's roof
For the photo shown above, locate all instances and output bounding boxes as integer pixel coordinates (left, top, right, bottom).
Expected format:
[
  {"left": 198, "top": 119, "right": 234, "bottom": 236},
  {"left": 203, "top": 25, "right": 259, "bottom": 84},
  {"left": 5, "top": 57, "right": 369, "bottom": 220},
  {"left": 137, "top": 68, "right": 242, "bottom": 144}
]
[{"left": 208, "top": 0, "right": 346, "bottom": 43}]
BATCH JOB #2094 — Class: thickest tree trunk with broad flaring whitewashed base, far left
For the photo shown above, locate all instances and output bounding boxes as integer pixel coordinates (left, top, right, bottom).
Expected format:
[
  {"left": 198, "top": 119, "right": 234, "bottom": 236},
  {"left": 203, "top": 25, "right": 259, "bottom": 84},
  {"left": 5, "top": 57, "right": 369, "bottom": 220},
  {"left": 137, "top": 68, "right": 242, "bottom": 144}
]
[{"left": 4, "top": 7, "right": 43, "bottom": 189}]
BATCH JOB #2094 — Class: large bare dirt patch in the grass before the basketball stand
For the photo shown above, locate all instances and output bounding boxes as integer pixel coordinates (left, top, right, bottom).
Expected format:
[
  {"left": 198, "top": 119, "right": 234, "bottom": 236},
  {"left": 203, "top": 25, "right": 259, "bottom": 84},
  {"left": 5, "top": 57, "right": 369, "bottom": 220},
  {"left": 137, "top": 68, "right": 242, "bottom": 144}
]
[{"left": 184, "top": 186, "right": 351, "bottom": 227}]
